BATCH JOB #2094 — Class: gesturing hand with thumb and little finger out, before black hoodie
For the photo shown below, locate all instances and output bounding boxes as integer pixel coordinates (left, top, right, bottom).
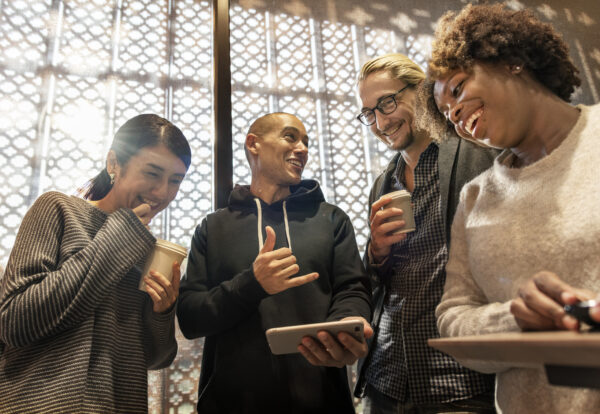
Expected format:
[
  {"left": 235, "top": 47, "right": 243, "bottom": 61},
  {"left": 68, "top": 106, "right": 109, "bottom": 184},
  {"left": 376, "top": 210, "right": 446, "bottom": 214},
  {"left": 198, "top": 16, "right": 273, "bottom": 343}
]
[{"left": 252, "top": 226, "right": 319, "bottom": 295}]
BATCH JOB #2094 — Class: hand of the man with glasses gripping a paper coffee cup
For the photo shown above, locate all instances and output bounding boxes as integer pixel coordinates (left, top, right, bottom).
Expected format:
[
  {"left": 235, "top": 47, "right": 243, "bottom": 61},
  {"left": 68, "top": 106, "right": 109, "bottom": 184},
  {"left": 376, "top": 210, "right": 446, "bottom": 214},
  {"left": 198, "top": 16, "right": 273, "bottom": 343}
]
[{"left": 369, "top": 195, "right": 406, "bottom": 263}]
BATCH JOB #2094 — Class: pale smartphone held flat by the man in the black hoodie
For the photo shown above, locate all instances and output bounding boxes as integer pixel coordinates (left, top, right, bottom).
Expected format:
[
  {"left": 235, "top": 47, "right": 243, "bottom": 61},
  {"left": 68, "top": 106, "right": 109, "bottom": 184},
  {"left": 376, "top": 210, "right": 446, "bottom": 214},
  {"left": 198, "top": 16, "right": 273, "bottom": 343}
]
[{"left": 266, "top": 320, "right": 365, "bottom": 355}]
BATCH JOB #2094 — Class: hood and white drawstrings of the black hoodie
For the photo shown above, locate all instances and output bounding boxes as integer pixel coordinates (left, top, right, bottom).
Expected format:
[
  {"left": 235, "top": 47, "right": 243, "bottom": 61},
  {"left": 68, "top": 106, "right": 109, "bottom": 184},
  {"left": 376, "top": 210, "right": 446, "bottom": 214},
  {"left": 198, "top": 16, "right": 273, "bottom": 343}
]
[{"left": 229, "top": 180, "right": 325, "bottom": 252}]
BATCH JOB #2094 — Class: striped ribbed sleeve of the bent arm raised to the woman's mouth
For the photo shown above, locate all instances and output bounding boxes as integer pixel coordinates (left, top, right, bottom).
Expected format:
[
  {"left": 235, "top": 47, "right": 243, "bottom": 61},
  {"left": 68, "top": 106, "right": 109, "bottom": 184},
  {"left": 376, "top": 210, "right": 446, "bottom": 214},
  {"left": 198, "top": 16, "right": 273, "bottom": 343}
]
[{"left": 0, "top": 192, "right": 154, "bottom": 347}]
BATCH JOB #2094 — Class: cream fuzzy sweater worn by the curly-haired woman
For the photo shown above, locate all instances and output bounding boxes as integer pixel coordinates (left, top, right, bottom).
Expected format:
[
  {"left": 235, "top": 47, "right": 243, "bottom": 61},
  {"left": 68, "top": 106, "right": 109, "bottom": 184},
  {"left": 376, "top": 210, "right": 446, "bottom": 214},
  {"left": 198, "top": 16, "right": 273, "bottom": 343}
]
[{"left": 436, "top": 105, "right": 600, "bottom": 414}]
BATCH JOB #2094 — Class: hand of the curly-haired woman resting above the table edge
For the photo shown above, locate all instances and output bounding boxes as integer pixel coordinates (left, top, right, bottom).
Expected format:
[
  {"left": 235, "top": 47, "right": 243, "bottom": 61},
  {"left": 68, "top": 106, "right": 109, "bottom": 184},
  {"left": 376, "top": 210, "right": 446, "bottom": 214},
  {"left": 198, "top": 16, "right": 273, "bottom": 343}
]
[{"left": 510, "top": 271, "right": 600, "bottom": 331}]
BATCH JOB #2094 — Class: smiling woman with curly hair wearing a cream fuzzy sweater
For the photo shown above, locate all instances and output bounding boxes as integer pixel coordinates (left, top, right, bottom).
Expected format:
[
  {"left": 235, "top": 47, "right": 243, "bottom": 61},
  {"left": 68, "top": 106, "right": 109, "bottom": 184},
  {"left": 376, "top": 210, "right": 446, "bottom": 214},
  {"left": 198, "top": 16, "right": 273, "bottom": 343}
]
[{"left": 421, "top": 5, "right": 600, "bottom": 413}]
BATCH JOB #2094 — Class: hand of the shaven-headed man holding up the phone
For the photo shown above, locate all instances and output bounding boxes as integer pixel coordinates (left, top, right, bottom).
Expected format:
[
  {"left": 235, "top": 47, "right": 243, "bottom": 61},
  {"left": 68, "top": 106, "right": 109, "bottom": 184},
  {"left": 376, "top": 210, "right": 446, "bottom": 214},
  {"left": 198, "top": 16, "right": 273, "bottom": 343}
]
[{"left": 298, "top": 316, "right": 373, "bottom": 368}]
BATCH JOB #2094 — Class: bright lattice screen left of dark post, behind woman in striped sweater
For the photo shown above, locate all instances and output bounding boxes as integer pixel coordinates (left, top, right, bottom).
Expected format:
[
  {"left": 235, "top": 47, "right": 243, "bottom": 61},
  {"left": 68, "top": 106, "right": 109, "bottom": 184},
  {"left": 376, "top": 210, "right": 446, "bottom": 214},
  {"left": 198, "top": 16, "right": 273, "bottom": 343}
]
[{"left": 0, "top": 0, "right": 214, "bottom": 413}]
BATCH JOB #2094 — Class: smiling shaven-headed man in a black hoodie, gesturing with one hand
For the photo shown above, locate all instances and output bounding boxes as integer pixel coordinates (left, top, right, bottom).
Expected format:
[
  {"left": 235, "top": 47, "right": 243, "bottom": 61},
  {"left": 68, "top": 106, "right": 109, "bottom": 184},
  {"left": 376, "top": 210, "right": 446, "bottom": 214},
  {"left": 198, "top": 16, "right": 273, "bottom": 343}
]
[{"left": 177, "top": 113, "right": 373, "bottom": 413}]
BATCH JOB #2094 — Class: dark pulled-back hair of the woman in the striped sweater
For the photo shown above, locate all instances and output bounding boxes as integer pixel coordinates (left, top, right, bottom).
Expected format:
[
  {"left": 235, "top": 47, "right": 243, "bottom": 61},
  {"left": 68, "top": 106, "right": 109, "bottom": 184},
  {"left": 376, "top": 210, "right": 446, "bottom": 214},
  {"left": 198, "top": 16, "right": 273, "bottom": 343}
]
[{"left": 80, "top": 114, "right": 192, "bottom": 200}]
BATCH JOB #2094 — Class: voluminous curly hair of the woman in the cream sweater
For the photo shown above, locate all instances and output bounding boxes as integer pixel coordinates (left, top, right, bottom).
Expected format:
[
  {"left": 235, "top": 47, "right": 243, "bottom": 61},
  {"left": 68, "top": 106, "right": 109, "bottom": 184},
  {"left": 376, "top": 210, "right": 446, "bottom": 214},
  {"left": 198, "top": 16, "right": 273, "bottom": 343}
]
[{"left": 418, "top": 4, "right": 581, "bottom": 139}]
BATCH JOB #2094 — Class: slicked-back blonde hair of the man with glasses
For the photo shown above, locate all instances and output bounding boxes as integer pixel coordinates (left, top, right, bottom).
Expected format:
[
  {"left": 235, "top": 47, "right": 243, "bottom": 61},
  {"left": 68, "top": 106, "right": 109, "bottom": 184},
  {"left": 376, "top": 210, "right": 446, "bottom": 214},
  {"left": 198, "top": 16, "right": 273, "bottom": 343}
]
[{"left": 358, "top": 53, "right": 425, "bottom": 86}]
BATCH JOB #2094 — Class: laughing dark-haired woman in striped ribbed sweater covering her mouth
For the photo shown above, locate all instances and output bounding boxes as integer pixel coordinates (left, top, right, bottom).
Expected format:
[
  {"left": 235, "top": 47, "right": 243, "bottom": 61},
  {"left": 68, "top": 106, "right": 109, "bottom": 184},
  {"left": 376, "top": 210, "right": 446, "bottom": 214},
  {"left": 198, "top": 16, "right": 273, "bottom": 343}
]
[{"left": 0, "top": 114, "right": 191, "bottom": 413}]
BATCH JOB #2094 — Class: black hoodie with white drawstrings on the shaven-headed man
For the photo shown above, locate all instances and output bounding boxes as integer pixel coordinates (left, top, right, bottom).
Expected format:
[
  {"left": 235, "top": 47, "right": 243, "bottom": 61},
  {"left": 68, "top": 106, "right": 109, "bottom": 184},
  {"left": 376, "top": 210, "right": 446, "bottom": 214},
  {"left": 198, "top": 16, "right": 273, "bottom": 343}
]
[{"left": 177, "top": 180, "right": 371, "bottom": 413}]
